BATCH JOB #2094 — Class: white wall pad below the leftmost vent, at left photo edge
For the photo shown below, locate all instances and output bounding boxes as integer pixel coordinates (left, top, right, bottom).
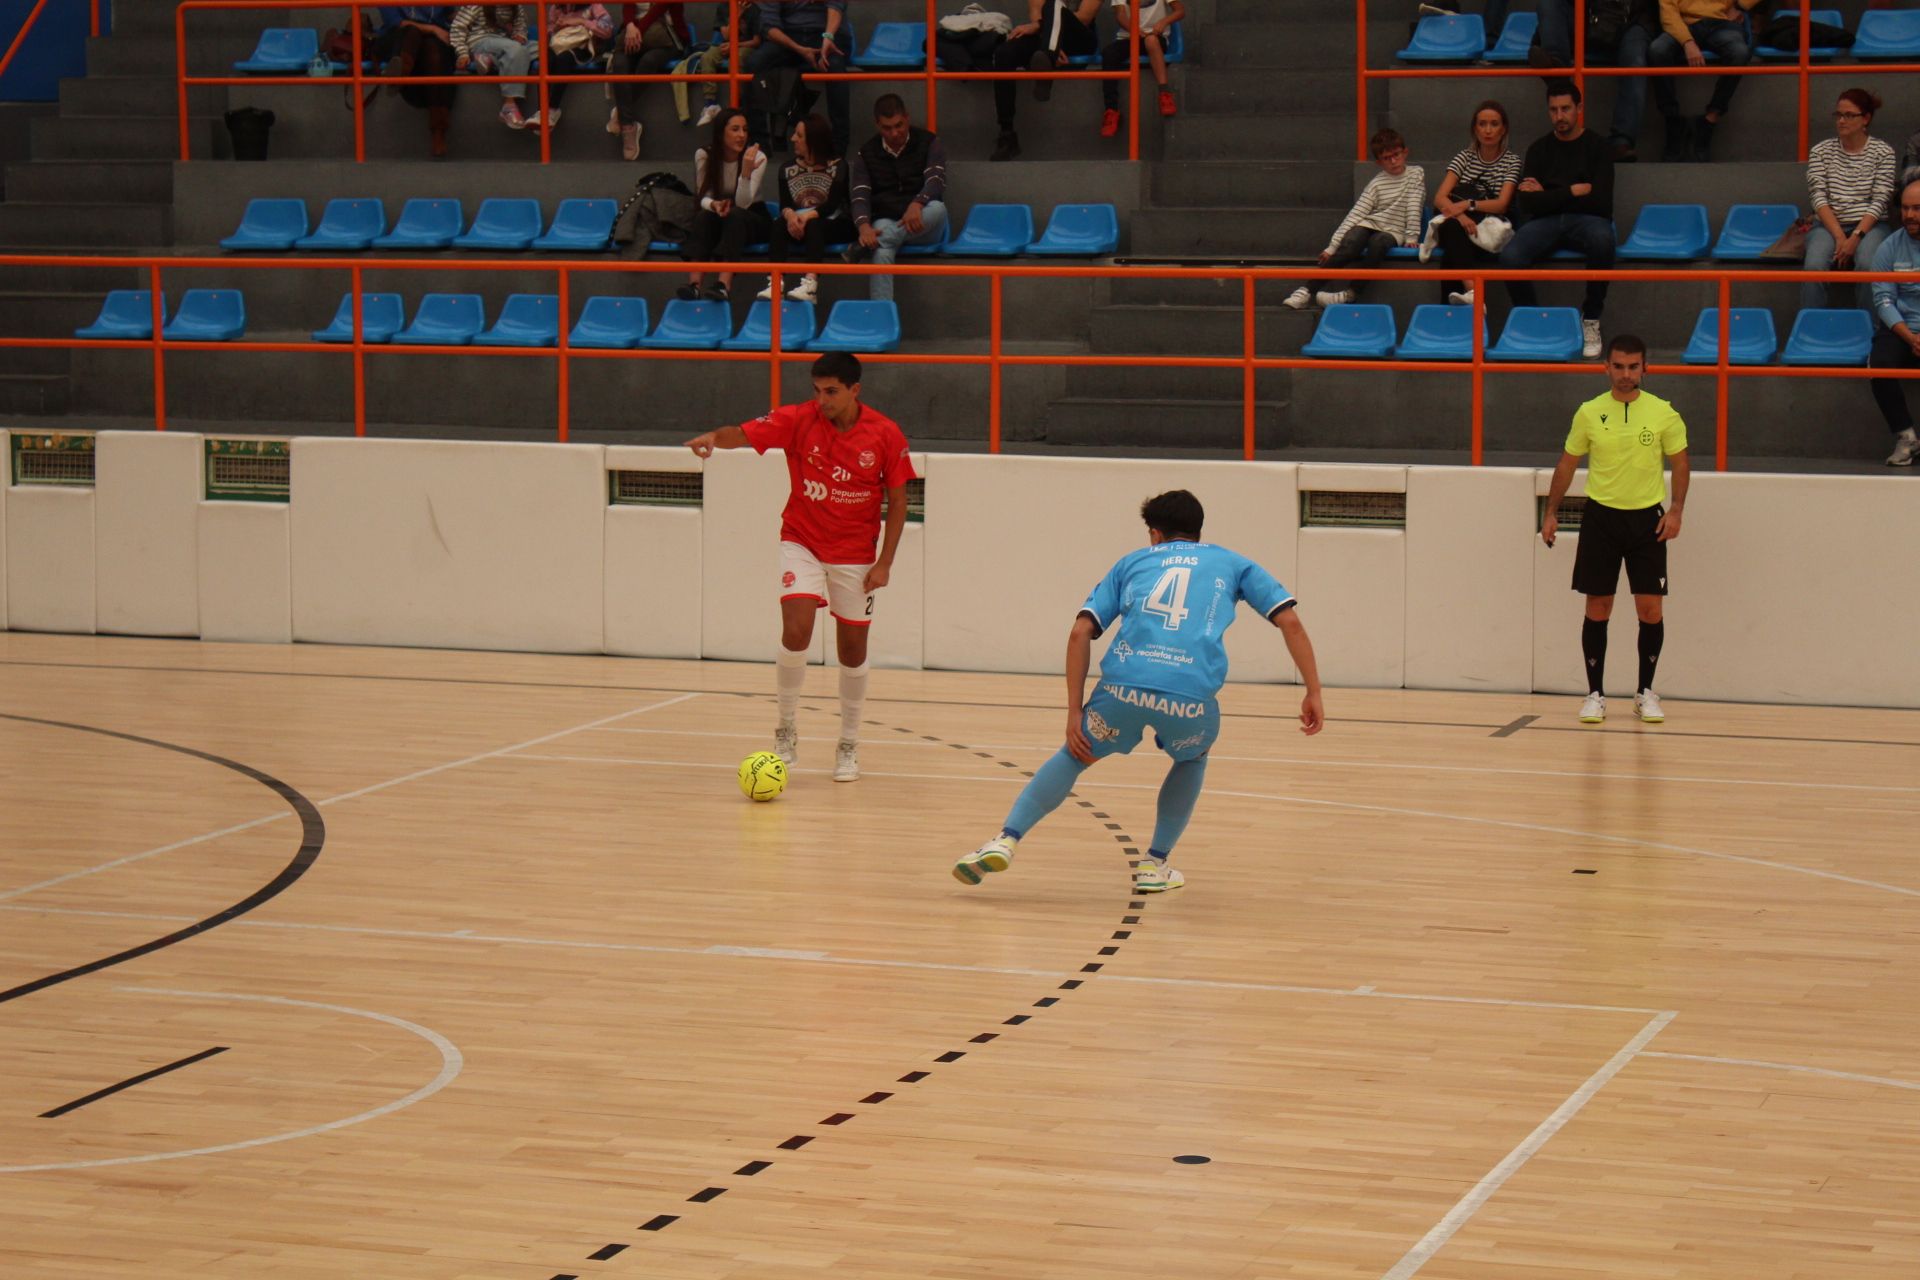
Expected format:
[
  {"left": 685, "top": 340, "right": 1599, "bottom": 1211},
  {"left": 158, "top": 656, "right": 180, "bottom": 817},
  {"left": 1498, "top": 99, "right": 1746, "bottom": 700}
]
[{"left": 6, "top": 486, "right": 94, "bottom": 635}]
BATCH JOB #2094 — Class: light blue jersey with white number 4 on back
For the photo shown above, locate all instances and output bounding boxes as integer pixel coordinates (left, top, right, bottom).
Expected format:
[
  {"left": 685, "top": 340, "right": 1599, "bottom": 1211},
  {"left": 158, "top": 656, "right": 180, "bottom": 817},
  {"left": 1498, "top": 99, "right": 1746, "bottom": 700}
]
[{"left": 1081, "top": 541, "right": 1294, "bottom": 699}]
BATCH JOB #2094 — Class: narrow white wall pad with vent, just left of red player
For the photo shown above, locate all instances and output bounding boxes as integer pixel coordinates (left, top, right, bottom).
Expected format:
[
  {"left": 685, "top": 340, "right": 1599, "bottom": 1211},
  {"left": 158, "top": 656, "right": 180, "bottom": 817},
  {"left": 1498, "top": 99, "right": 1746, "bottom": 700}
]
[{"left": 603, "top": 445, "right": 705, "bottom": 658}]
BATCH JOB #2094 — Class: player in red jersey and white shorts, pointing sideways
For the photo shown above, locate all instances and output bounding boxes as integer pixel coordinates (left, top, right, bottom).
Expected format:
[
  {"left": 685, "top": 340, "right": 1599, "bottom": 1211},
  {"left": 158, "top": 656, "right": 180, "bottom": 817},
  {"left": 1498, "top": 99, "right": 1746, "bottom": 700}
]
[{"left": 687, "top": 351, "right": 914, "bottom": 783}]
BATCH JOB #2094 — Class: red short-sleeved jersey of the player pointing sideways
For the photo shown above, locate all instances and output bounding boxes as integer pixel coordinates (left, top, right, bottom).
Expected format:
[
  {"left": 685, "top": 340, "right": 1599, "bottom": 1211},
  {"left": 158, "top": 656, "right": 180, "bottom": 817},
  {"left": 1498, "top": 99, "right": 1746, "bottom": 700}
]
[{"left": 741, "top": 401, "right": 914, "bottom": 564}]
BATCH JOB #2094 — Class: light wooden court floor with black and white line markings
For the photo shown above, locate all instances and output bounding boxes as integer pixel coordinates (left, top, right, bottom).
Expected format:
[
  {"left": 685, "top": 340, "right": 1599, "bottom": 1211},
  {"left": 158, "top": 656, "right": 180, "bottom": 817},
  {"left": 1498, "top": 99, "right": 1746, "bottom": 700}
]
[{"left": 0, "top": 633, "right": 1920, "bottom": 1280}]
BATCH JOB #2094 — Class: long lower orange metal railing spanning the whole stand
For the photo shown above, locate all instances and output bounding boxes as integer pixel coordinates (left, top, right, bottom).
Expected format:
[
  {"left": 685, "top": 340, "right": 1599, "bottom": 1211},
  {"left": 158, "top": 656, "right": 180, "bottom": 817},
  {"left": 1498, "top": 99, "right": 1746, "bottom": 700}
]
[{"left": 0, "top": 253, "right": 1920, "bottom": 470}]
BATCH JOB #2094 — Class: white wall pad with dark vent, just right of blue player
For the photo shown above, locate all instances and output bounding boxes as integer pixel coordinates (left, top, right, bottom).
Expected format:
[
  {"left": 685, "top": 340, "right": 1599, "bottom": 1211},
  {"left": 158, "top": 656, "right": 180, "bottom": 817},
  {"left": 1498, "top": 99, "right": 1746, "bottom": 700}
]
[{"left": 1294, "top": 462, "right": 1407, "bottom": 689}]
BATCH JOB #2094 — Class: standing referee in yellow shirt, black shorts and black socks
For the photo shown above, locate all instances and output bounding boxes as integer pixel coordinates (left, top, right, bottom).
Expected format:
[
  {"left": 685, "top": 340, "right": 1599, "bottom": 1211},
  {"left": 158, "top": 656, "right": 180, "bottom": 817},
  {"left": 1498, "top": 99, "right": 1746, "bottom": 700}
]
[{"left": 1540, "top": 334, "right": 1692, "bottom": 723}]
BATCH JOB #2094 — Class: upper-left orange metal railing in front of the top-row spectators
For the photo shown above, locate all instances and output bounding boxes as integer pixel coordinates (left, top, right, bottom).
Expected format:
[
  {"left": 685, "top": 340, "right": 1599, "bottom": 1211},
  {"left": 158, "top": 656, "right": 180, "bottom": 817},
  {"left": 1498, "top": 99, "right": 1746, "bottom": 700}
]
[{"left": 176, "top": 0, "right": 1140, "bottom": 163}]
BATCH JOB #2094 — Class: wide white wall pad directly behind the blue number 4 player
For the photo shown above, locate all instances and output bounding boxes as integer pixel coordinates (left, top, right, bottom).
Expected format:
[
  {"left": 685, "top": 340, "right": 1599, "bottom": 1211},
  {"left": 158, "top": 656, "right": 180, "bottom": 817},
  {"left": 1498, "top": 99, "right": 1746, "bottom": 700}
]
[{"left": 925, "top": 455, "right": 1298, "bottom": 681}]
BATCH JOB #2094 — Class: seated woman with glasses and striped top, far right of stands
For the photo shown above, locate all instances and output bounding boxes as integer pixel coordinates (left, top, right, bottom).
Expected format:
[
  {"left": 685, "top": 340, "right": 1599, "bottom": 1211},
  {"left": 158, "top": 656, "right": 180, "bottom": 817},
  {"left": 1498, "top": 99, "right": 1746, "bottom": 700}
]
[{"left": 1801, "top": 88, "right": 1893, "bottom": 309}]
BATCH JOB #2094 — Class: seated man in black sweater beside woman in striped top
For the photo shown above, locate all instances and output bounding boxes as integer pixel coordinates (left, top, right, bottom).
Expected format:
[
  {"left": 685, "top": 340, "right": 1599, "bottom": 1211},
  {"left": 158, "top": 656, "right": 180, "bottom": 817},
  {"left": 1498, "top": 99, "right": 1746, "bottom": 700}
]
[{"left": 1500, "top": 81, "right": 1615, "bottom": 361}]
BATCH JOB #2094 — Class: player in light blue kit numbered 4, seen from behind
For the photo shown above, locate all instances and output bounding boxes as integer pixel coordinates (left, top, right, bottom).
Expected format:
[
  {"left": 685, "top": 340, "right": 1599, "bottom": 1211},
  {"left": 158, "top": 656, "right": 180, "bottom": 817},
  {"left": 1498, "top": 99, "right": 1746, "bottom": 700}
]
[{"left": 954, "top": 489, "right": 1325, "bottom": 892}]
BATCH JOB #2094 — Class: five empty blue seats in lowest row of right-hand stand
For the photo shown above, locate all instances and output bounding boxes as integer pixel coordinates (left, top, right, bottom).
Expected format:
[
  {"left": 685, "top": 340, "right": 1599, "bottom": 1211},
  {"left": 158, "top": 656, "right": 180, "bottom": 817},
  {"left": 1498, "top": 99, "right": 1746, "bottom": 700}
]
[{"left": 1300, "top": 303, "right": 1874, "bottom": 365}]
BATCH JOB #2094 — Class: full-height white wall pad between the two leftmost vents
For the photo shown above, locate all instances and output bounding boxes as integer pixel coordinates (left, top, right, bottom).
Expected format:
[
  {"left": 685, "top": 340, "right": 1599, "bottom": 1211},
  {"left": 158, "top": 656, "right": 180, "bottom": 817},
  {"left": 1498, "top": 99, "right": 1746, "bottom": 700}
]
[{"left": 94, "top": 432, "right": 204, "bottom": 635}]
